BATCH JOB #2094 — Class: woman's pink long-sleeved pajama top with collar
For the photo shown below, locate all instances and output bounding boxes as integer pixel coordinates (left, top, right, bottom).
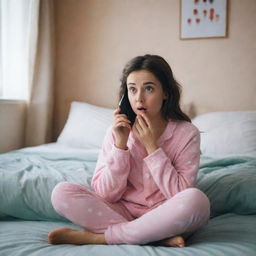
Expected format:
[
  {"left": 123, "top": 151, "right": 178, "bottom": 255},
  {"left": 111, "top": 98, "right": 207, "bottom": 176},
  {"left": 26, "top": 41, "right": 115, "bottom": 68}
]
[{"left": 92, "top": 120, "right": 200, "bottom": 217}]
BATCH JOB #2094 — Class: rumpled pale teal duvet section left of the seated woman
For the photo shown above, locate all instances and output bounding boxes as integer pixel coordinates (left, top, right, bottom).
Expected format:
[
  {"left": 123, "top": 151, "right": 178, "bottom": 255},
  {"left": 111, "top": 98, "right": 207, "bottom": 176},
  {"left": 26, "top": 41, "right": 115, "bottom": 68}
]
[{"left": 0, "top": 151, "right": 98, "bottom": 220}]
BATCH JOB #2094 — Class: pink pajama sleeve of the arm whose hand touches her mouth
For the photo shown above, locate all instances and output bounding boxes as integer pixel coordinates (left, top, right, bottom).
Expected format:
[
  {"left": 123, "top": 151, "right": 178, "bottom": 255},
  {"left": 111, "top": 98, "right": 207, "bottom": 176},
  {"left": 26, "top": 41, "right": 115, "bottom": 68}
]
[{"left": 144, "top": 127, "right": 200, "bottom": 199}]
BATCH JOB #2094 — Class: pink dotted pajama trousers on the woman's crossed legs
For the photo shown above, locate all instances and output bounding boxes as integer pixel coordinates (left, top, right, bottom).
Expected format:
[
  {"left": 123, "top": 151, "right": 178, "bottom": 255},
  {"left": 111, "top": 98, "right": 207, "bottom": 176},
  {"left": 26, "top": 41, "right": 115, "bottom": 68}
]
[{"left": 51, "top": 182, "right": 210, "bottom": 244}]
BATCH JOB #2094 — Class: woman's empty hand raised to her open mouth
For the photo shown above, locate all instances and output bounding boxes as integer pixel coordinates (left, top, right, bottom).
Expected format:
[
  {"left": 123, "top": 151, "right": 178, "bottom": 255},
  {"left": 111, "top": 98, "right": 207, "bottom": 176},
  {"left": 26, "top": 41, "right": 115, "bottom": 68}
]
[{"left": 132, "top": 113, "right": 158, "bottom": 154}]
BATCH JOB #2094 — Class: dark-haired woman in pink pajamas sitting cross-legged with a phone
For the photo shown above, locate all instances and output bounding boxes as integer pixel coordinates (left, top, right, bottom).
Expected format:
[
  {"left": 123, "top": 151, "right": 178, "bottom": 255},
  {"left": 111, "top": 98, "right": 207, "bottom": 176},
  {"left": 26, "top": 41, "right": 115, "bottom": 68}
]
[{"left": 48, "top": 55, "right": 210, "bottom": 247}]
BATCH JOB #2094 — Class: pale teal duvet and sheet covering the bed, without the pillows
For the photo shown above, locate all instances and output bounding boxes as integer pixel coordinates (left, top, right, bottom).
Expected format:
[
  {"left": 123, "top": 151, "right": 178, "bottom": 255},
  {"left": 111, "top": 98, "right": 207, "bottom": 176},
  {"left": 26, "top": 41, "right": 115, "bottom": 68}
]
[{"left": 0, "top": 150, "right": 256, "bottom": 256}]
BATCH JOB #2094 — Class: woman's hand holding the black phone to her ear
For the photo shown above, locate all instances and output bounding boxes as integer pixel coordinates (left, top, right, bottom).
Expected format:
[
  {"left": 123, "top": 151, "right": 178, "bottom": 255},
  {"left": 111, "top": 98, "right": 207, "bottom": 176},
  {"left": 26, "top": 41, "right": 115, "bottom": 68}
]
[{"left": 112, "top": 108, "right": 131, "bottom": 149}]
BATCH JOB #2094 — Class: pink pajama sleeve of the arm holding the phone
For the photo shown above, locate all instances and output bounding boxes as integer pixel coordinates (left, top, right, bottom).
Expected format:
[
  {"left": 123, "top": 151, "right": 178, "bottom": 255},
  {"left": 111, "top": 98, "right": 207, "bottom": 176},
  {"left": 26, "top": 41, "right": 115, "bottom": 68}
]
[{"left": 91, "top": 128, "right": 130, "bottom": 202}]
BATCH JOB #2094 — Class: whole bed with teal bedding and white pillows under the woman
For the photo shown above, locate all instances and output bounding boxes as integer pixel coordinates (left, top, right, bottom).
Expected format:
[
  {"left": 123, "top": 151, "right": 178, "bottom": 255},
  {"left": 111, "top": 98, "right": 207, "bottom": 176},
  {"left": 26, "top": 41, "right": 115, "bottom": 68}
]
[{"left": 0, "top": 102, "right": 256, "bottom": 256}]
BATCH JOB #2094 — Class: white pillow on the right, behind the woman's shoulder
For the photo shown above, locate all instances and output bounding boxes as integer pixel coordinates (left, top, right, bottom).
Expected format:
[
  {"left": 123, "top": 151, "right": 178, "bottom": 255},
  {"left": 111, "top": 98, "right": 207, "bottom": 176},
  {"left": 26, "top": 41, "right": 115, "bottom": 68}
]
[{"left": 192, "top": 111, "right": 256, "bottom": 157}]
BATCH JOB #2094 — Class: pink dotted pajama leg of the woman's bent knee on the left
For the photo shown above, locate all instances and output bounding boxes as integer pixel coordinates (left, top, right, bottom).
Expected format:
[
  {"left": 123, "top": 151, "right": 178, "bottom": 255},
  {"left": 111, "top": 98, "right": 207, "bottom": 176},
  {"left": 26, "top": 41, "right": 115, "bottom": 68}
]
[{"left": 51, "top": 182, "right": 134, "bottom": 233}]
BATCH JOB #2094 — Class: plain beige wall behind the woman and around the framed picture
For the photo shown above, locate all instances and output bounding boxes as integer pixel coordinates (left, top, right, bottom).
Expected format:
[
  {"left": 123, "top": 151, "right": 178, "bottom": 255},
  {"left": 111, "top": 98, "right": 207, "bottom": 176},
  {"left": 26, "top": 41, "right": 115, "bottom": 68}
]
[{"left": 54, "top": 0, "right": 256, "bottom": 137}]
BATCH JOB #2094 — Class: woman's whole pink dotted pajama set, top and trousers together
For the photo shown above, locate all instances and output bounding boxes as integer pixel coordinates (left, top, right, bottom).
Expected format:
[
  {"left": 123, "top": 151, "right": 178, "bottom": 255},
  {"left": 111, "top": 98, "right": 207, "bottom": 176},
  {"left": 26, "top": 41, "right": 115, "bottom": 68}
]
[{"left": 52, "top": 121, "right": 210, "bottom": 244}]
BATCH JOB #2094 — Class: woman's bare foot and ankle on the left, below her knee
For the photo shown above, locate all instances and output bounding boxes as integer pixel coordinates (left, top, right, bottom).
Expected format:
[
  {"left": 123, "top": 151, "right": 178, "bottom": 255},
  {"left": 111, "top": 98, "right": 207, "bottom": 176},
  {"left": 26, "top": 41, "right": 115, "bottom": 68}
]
[{"left": 48, "top": 228, "right": 106, "bottom": 245}]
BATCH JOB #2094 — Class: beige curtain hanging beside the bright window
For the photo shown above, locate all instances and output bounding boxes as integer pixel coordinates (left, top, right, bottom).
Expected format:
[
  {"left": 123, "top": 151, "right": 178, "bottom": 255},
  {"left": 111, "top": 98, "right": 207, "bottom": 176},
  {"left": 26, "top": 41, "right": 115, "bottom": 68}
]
[{"left": 25, "top": 0, "right": 54, "bottom": 146}]
